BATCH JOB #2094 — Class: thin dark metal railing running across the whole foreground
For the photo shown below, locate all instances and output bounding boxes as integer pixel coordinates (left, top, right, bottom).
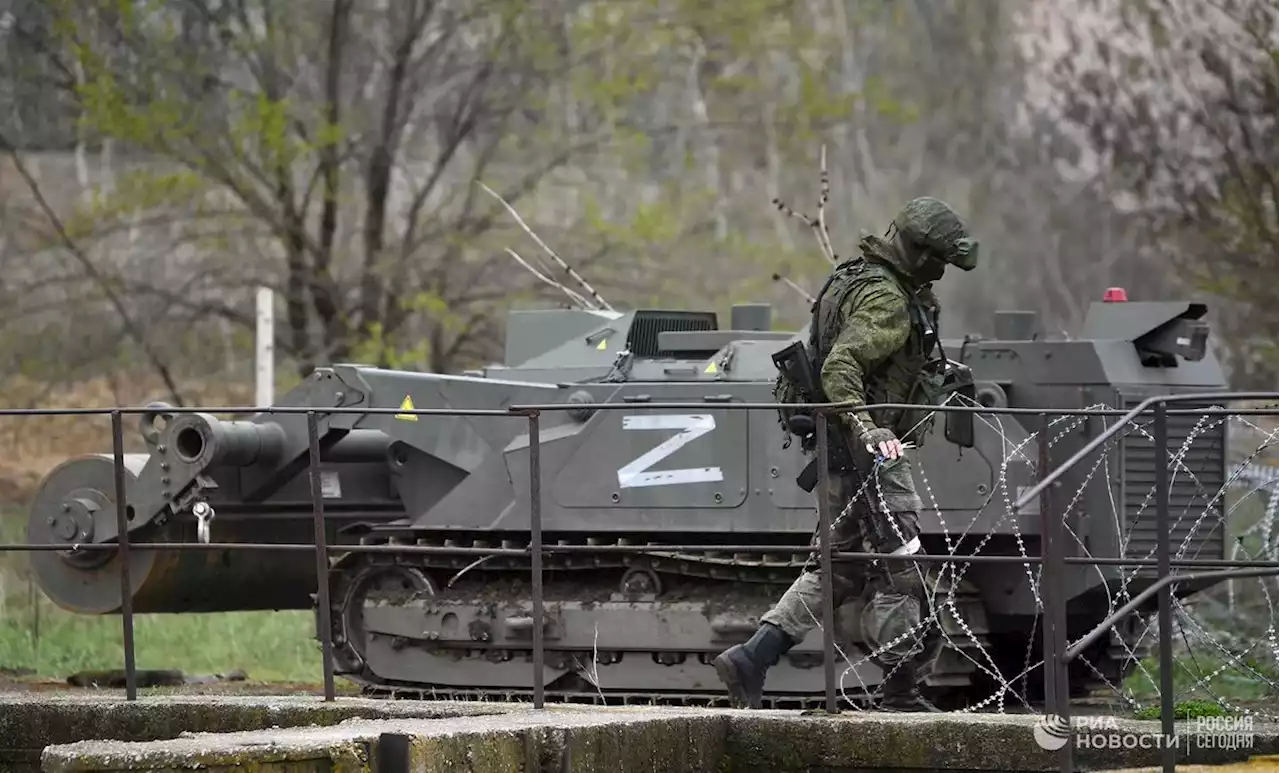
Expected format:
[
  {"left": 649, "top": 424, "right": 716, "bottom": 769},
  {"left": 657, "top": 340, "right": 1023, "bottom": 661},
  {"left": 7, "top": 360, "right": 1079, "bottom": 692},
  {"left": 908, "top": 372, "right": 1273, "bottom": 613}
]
[{"left": 0, "top": 392, "right": 1280, "bottom": 772}]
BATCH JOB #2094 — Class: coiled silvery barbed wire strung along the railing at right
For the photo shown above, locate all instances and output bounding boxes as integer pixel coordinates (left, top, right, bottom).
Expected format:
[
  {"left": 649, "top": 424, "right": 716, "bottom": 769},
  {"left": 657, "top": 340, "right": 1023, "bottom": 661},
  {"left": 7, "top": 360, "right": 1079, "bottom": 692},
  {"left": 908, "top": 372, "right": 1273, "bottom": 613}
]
[{"left": 801, "top": 395, "right": 1280, "bottom": 721}]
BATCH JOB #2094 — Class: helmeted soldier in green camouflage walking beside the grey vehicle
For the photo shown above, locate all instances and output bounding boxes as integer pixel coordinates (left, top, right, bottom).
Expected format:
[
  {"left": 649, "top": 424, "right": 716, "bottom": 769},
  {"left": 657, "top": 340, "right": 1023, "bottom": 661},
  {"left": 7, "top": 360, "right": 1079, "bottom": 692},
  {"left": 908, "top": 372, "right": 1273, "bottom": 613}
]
[{"left": 716, "top": 197, "right": 978, "bottom": 712}]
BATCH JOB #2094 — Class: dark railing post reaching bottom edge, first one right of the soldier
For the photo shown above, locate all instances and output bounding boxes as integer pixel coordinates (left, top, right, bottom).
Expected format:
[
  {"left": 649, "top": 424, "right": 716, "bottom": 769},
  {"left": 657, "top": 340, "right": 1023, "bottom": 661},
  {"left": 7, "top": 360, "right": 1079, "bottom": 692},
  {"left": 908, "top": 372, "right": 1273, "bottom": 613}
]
[{"left": 1038, "top": 413, "right": 1075, "bottom": 773}]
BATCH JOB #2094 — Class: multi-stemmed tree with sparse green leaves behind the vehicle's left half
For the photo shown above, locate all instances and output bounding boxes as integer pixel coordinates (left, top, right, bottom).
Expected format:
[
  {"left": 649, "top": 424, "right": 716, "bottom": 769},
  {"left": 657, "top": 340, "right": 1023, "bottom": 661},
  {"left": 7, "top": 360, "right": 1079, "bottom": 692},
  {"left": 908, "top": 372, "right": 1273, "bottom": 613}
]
[{"left": 5, "top": 0, "right": 624, "bottom": 372}]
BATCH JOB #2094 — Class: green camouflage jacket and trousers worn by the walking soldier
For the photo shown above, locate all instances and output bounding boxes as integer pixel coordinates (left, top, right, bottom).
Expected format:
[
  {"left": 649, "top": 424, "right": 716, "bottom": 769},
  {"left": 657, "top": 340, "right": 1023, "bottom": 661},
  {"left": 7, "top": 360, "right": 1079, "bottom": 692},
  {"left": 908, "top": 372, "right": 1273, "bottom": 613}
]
[{"left": 762, "top": 249, "right": 936, "bottom": 668}]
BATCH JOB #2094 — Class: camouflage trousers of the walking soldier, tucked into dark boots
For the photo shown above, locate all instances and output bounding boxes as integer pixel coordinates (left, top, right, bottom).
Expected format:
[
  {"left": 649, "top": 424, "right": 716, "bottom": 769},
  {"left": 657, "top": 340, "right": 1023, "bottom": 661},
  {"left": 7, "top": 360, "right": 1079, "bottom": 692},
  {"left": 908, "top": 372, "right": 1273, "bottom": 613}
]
[{"left": 760, "top": 450, "right": 931, "bottom": 668}]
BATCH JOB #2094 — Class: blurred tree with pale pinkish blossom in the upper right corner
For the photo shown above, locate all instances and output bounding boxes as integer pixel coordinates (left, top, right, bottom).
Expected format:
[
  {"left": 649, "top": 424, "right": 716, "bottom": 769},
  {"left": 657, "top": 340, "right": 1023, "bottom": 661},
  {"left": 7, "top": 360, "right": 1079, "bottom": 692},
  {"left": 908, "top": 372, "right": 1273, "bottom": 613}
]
[{"left": 1027, "top": 0, "right": 1280, "bottom": 388}]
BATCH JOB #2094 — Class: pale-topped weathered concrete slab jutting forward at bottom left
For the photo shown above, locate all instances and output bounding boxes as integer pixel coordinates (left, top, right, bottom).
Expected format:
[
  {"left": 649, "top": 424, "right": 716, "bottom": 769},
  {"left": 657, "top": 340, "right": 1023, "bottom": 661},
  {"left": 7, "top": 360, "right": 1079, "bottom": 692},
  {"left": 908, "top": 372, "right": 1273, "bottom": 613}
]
[{"left": 42, "top": 709, "right": 727, "bottom": 773}]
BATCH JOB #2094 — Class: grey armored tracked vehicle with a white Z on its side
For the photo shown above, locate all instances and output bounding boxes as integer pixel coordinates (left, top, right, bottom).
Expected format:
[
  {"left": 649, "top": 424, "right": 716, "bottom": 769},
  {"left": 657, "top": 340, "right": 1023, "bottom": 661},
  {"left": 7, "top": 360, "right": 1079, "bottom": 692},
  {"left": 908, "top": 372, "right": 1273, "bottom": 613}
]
[{"left": 28, "top": 293, "right": 1226, "bottom": 706}]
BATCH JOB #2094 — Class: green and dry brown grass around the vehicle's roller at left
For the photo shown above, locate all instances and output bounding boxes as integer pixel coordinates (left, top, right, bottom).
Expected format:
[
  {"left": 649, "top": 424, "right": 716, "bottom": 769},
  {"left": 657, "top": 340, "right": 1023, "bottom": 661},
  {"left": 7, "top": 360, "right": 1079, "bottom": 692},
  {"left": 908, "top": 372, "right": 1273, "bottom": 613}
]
[{"left": 0, "top": 378, "right": 323, "bottom": 683}]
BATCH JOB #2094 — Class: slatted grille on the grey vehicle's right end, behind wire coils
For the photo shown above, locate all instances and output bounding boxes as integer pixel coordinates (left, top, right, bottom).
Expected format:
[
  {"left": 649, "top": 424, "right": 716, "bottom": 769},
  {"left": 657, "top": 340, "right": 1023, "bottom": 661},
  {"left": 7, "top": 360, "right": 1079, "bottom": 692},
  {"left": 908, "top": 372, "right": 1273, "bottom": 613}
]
[{"left": 1121, "top": 401, "right": 1228, "bottom": 558}]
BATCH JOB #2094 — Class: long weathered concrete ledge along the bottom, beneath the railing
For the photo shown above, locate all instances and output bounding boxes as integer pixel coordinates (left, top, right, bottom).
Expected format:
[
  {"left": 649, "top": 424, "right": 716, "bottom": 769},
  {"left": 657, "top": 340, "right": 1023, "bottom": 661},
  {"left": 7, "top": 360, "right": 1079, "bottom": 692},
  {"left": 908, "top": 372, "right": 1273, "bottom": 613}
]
[{"left": 10, "top": 697, "right": 1280, "bottom": 773}]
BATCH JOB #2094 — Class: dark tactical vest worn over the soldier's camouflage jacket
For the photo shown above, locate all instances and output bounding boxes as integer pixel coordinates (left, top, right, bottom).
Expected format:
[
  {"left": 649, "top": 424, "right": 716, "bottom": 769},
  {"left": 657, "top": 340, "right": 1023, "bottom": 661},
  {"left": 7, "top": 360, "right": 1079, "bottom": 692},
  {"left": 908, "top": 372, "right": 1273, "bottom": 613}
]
[{"left": 809, "top": 257, "right": 940, "bottom": 445}]
